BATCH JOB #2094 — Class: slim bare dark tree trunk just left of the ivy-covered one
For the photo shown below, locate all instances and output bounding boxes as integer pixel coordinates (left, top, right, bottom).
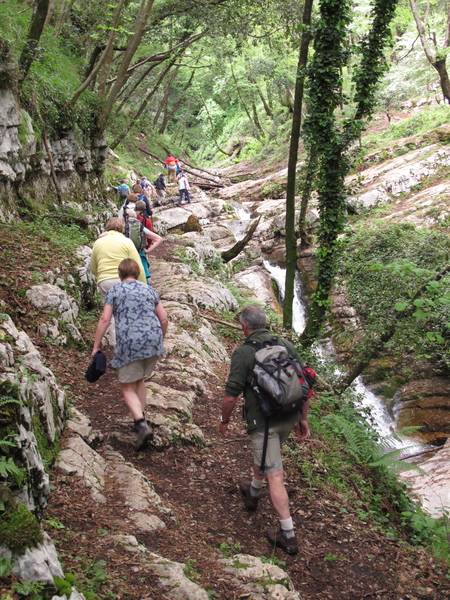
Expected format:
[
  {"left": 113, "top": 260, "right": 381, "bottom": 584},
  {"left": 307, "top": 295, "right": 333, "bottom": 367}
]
[{"left": 283, "top": 0, "right": 313, "bottom": 329}]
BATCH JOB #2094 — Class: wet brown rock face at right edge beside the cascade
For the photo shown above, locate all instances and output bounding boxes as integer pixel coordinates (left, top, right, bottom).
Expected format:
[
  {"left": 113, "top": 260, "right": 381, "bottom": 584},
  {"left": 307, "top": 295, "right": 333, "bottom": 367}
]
[{"left": 394, "top": 377, "right": 450, "bottom": 443}]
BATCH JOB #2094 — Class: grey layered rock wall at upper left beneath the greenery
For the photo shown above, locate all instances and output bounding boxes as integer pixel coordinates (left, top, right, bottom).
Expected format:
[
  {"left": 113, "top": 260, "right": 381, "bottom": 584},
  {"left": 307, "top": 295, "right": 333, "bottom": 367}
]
[{"left": 0, "top": 89, "right": 108, "bottom": 222}]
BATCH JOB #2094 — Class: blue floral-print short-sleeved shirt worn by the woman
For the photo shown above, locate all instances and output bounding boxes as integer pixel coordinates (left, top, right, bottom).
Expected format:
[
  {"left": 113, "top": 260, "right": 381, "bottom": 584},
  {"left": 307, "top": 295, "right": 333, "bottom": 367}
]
[{"left": 104, "top": 280, "right": 164, "bottom": 369}]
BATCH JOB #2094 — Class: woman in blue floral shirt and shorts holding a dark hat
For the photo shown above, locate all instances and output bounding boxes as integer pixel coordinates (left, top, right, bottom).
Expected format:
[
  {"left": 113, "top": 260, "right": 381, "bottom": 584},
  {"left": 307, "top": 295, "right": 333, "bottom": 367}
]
[{"left": 91, "top": 258, "right": 168, "bottom": 450}]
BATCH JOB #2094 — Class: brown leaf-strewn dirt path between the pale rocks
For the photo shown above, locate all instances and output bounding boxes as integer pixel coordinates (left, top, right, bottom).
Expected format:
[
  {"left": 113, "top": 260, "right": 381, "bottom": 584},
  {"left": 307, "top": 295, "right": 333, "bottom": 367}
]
[{"left": 36, "top": 241, "right": 449, "bottom": 600}]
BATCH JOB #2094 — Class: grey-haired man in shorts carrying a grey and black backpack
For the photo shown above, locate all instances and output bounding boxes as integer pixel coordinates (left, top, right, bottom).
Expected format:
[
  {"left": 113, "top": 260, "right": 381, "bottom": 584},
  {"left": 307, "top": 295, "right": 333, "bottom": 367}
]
[{"left": 219, "top": 304, "right": 315, "bottom": 554}]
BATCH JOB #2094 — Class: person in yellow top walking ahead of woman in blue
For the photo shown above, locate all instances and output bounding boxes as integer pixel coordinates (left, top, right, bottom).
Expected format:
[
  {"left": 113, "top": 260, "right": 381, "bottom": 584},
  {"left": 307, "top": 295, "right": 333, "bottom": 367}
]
[{"left": 91, "top": 218, "right": 145, "bottom": 346}]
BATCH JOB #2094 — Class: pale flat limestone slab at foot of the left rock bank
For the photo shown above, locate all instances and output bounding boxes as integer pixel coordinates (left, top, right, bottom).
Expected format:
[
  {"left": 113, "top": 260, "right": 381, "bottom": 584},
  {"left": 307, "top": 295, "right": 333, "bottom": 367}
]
[{"left": 56, "top": 435, "right": 107, "bottom": 504}]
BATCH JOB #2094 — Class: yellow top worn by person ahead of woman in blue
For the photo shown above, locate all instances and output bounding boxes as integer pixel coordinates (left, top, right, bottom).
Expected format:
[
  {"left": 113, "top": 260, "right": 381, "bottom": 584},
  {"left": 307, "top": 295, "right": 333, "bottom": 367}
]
[{"left": 91, "top": 231, "right": 146, "bottom": 283}]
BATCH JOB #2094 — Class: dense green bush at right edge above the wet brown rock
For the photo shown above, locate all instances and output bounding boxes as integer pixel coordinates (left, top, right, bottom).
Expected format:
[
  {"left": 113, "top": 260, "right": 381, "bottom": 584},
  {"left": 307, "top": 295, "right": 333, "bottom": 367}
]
[{"left": 340, "top": 222, "right": 450, "bottom": 374}]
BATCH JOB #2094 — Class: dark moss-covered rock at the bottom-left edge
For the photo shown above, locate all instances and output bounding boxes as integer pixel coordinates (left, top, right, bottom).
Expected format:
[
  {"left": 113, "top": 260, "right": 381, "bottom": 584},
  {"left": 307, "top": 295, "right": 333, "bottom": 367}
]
[{"left": 0, "top": 503, "right": 43, "bottom": 554}]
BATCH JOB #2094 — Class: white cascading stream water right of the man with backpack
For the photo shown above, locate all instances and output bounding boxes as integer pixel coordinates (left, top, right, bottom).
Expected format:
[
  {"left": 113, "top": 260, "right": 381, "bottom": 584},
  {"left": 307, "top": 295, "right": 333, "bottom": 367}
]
[{"left": 264, "top": 260, "right": 411, "bottom": 448}]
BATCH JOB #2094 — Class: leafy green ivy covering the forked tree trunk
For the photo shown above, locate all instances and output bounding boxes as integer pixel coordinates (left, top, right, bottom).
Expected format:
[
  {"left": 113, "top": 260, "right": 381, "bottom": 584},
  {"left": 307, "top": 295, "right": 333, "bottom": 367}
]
[{"left": 302, "top": 0, "right": 397, "bottom": 343}]
